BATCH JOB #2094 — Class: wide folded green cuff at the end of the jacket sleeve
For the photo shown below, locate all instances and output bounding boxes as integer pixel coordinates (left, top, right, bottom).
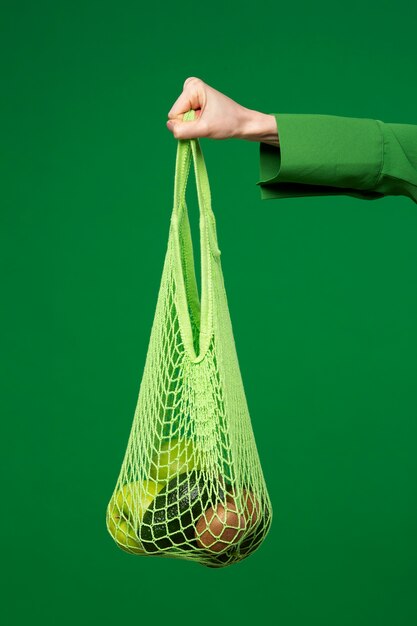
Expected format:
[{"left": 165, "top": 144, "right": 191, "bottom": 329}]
[{"left": 256, "top": 113, "right": 384, "bottom": 198}]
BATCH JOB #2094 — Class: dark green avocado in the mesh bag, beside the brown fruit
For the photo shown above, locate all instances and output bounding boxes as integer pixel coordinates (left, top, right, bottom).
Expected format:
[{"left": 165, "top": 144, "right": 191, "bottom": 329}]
[{"left": 138, "top": 471, "right": 225, "bottom": 552}]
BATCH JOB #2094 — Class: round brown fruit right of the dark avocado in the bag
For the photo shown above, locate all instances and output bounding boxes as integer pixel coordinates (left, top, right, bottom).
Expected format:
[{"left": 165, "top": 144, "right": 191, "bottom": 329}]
[{"left": 195, "top": 499, "right": 246, "bottom": 552}]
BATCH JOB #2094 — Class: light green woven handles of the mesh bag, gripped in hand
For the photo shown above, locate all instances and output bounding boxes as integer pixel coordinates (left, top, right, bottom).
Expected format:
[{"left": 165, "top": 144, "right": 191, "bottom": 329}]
[{"left": 171, "top": 110, "right": 221, "bottom": 363}]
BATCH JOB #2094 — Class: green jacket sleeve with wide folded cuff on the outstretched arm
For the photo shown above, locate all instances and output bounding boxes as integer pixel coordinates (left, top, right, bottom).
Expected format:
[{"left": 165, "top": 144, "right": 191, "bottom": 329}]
[{"left": 256, "top": 113, "right": 417, "bottom": 203}]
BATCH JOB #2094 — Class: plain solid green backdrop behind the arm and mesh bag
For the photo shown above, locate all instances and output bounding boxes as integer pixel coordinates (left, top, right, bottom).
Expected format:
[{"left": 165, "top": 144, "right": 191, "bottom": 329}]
[{"left": 0, "top": 0, "right": 417, "bottom": 626}]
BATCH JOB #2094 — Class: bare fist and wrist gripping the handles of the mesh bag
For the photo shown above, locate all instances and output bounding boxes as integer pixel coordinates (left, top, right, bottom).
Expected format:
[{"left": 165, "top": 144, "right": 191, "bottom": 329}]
[{"left": 167, "top": 76, "right": 279, "bottom": 146}]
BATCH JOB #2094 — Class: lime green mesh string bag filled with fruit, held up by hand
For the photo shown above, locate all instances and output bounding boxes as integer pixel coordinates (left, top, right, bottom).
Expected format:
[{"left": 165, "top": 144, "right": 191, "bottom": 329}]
[{"left": 106, "top": 110, "right": 272, "bottom": 567}]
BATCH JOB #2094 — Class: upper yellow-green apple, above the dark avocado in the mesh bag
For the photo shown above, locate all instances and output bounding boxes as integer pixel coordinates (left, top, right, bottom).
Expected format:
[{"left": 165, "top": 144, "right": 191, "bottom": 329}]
[{"left": 150, "top": 438, "right": 201, "bottom": 483}]
